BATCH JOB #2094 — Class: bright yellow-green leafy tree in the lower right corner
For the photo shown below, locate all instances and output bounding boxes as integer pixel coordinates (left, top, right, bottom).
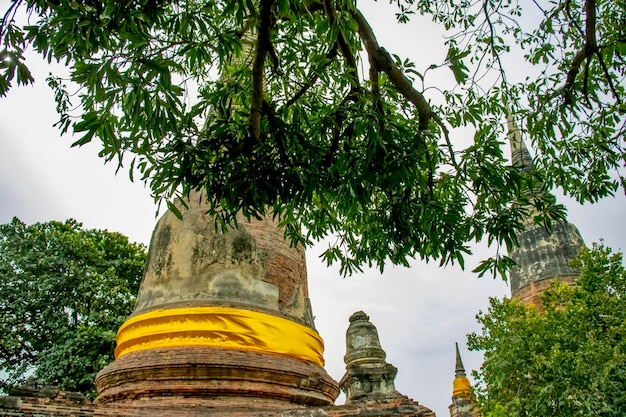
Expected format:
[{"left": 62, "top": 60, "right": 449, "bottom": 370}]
[{"left": 469, "top": 245, "right": 626, "bottom": 417}]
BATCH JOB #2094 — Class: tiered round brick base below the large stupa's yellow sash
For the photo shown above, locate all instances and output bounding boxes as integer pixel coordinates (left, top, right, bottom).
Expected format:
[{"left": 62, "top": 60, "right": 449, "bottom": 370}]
[{"left": 94, "top": 346, "right": 339, "bottom": 417}]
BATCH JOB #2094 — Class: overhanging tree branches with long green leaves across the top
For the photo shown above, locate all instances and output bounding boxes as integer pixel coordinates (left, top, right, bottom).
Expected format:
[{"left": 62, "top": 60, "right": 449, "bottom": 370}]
[{"left": 0, "top": 0, "right": 626, "bottom": 273}]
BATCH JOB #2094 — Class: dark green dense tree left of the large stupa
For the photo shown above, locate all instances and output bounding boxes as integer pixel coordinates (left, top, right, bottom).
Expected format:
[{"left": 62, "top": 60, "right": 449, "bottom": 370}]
[{"left": 0, "top": 218, "right": 146, "bottom": 396}]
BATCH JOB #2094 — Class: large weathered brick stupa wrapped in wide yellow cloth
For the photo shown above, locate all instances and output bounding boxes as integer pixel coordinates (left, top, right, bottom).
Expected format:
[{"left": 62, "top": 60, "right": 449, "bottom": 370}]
[{"left": 95, "top": 193, "right": 339, "bottom": 417}]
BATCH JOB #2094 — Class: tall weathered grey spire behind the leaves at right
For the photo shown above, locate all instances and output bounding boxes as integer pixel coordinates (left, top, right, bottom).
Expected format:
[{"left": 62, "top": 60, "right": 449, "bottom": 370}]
[{"left": 507, "top": 115, "right": 584, "bottom": 308}]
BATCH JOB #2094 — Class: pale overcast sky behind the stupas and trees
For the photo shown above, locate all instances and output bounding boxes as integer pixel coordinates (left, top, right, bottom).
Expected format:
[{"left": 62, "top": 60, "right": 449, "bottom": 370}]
[{"left": 0, "top": 0, "right": 626, "bottom": 417}]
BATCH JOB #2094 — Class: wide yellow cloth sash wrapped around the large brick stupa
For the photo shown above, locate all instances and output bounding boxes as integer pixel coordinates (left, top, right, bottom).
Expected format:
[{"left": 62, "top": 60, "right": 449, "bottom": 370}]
[{"left": 115, "top": 307, "right": 324, "bottom": 366}]
